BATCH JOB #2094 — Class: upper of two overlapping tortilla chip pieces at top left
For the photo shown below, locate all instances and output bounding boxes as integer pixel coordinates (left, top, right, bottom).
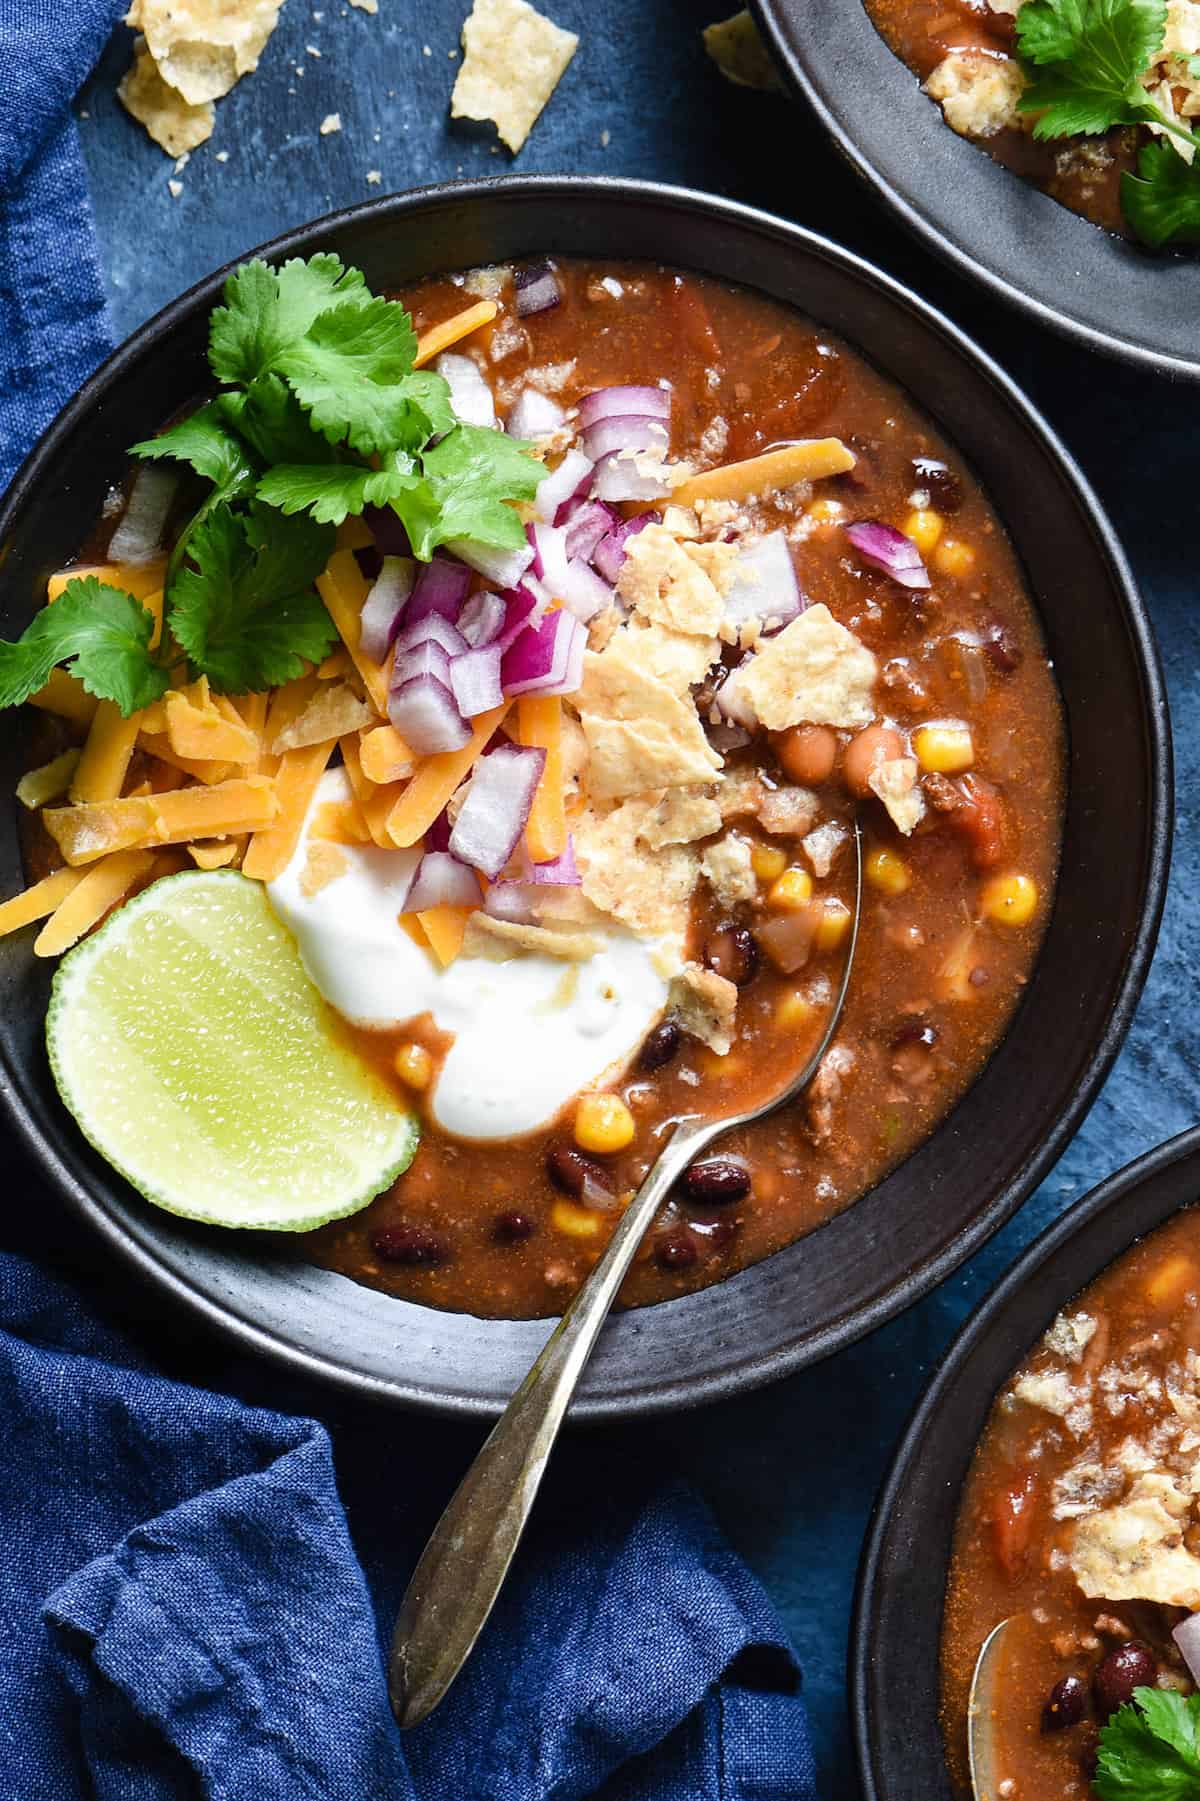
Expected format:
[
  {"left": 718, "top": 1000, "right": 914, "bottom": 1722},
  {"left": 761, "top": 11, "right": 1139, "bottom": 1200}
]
[{"left": 124, "top": 0, "right": 283, "bottom": 106}]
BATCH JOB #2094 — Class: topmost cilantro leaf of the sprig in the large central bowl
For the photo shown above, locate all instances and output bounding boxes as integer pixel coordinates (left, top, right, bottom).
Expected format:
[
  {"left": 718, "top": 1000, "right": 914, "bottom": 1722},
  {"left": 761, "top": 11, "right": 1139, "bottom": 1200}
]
[{"left": 209, "top": 252, "right": 369, "bottom": 387}]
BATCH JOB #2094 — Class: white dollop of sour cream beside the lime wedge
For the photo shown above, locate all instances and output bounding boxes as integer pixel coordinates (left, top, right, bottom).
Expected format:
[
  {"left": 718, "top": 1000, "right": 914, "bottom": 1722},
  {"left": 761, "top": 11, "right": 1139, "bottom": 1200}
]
[{"left": 267, "top": 769, "right": 667, "bottom": 1138}]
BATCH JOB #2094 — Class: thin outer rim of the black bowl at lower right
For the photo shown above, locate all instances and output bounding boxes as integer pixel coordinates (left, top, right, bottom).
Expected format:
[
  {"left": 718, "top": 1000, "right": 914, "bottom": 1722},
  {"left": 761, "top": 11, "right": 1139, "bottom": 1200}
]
[{"left": 847, "top": 1126, "right": 1200, "bottom": 1801}]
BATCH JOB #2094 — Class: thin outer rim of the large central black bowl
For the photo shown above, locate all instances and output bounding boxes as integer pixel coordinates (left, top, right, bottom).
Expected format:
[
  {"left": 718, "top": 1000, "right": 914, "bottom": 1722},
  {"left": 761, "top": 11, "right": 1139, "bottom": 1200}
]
[{"left": 0, "top": 175, "right": 1173, "bottom": 1421}]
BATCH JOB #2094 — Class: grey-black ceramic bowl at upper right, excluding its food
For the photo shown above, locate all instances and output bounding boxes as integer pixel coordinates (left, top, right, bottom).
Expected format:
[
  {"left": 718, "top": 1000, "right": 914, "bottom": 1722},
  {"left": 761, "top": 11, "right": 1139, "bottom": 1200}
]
[{"left": 751, "top": 0, "right": 1200, "bottom": 380}]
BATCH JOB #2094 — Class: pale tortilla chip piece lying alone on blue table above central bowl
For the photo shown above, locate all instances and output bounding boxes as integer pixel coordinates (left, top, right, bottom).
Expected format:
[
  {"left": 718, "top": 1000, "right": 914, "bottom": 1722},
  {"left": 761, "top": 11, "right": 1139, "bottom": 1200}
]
[{"left": 450, "top": 0, "right": 578, "bottom": 155}]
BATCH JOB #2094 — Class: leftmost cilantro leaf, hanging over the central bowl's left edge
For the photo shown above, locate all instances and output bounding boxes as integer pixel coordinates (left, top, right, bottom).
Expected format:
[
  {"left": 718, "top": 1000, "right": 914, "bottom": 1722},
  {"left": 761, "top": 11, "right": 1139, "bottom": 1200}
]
[{"left": 0, "top": 575, "right": 168, "bottom": 719}]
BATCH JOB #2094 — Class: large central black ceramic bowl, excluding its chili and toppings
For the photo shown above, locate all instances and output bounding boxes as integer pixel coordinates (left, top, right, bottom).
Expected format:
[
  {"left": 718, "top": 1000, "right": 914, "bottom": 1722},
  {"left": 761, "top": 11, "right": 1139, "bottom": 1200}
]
[{"left": 0, "top": 178, "right": 1171, "bottom": 1417}]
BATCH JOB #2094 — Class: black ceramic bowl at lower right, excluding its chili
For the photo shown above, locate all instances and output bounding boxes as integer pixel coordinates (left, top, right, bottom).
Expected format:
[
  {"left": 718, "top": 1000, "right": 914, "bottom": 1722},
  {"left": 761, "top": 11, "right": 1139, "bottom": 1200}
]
[{"left": 850, "top": 1129, "right": 1200, "bottom": 1801}]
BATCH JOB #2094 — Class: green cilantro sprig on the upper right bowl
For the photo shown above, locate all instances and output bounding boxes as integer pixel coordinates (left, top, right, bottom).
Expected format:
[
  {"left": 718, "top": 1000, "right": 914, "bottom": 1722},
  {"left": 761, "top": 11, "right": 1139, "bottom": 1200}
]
[{"left": 1016, "top": 0, "right": 1200, "bottom": 250}]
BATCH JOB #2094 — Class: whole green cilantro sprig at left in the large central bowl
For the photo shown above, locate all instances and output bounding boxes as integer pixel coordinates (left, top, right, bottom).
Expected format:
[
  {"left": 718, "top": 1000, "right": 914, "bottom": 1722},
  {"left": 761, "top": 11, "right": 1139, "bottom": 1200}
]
[{"left": 0, "top": 254, "right": 544, "bottom": 717}]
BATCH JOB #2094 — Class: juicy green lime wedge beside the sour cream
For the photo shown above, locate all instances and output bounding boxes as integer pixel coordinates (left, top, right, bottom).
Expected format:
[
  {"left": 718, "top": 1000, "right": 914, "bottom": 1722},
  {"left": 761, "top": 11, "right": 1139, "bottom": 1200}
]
[{"left": 45, "top": 870, "right": 418, "bottom": 1232}]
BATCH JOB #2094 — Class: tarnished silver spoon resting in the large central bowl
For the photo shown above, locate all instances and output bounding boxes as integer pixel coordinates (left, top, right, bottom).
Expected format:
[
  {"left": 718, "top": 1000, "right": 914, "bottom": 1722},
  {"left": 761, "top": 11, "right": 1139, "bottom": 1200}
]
[{"left": 387, "top": 821, "right": 863, "bottom": 1727}]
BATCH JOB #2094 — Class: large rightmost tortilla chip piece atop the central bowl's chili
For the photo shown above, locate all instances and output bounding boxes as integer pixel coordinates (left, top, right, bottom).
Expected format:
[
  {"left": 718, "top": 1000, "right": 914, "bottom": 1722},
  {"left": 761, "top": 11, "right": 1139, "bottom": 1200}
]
[{"left": 723, "top": 603, "right": 876, "bottom": 731}]
